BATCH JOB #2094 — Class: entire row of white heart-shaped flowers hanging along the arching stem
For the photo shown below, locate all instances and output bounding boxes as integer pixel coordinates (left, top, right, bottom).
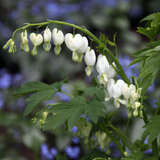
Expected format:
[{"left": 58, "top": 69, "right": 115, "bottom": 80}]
[{"left": 4, "top": 27, "right": 143, "bottom": 117}]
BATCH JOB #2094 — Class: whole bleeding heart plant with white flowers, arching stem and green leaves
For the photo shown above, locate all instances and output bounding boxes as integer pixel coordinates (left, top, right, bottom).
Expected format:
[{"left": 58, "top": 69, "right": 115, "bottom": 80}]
[{"left": 4, "top": 13, "right": 160, "bottom": 160}]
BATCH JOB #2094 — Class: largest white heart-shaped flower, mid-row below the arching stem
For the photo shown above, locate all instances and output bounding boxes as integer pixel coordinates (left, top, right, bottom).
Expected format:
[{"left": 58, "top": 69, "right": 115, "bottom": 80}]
[{"left": 65, "top": 33, "right": 88, "bottom": 63}]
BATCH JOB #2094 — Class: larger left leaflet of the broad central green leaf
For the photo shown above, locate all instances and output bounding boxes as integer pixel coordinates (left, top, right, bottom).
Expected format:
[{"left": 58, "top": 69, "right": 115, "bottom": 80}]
[{"left": 44, "top": 96, "right": 85, "bottom": 129}]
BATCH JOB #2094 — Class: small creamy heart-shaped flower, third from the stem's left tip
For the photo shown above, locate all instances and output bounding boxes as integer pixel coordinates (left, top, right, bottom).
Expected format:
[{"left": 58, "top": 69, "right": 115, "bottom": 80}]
[{"left": 30, "top": 33, "right": 43, "bottom": 56}]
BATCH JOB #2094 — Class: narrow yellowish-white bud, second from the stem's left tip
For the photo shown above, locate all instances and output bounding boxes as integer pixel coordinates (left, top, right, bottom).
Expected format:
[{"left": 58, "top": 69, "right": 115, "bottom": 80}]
[{"left": 21, "top": 30, "right": 29, "bottom": 52}]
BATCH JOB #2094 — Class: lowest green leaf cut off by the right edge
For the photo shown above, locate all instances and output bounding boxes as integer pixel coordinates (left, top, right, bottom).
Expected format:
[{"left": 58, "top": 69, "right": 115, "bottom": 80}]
[{"left": 144, "top": 115, "right": 160, "bottom": 144}]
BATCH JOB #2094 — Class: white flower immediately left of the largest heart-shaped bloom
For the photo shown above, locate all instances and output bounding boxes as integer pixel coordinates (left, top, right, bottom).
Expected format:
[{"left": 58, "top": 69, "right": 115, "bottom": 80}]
[{"left": 52, "top": 28, "right": 64, "bottom": 55}]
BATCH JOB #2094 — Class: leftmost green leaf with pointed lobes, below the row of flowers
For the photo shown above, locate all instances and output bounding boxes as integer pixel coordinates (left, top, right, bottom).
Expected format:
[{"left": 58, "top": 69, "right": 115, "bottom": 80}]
[{"left": 14, "top": 82, "right": 62, "bottom": 115}]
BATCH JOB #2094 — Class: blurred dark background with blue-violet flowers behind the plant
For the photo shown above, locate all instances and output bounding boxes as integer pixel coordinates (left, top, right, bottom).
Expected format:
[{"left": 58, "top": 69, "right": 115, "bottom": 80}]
[{"left": 0, "top": 0, "right": 160, "bottom": 160}]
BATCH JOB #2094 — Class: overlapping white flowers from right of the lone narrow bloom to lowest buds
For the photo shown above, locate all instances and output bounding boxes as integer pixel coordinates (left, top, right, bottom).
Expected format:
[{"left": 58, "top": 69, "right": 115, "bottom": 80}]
[{"left": 96, "top": 54, "right": 143, "bottom": 117}]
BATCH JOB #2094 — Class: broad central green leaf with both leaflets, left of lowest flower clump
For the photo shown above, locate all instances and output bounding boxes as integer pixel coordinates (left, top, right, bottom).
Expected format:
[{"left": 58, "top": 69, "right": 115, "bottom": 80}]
[{"left": 44, "top": 96, "right": 105, "bottom": 129}]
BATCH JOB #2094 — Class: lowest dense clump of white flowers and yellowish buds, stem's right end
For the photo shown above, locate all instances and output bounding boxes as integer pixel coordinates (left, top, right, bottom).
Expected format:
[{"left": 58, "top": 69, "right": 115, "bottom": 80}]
[{"left": 106, "top": 79, "right": 143, "bottom": 117}]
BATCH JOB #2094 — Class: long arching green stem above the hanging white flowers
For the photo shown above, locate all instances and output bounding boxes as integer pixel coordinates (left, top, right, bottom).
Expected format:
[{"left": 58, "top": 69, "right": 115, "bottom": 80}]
[{"left": 12, "top": 20, "right": 130, "bottom": 84}]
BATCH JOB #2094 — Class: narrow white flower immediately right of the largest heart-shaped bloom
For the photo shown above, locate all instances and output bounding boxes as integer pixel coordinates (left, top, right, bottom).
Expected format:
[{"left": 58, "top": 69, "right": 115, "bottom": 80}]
[{"left": 84, "top": 47, "right": 96, "bottom": 76}]
